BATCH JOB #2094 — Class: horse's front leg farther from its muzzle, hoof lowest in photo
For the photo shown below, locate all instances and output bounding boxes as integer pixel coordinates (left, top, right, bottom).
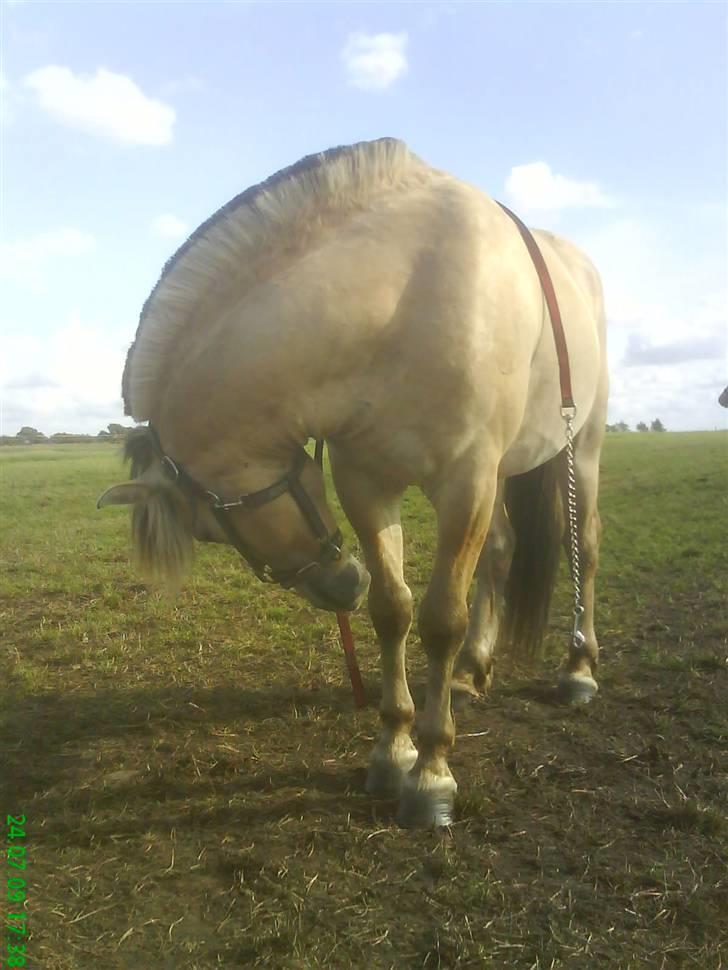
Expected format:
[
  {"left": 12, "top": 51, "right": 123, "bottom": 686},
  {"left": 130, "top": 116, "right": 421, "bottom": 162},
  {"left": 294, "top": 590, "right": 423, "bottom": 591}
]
[{"left": 398, "top": 457, "right": 497, "bottom": 827}]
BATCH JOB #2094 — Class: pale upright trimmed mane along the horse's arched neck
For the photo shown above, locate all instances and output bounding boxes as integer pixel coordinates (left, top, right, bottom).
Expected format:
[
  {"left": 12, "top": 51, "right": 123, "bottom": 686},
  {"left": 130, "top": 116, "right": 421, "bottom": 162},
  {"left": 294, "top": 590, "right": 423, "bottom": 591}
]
[{"left": 122, "top": 138, "right": 431, "bottom": 421}]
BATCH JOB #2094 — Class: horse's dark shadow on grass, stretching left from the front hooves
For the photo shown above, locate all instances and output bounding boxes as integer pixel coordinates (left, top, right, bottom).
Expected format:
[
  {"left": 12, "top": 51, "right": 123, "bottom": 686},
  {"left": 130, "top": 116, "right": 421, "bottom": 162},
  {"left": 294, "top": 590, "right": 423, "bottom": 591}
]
[{"left": 0, "top": 685, "right": 384, "bottom": 811}]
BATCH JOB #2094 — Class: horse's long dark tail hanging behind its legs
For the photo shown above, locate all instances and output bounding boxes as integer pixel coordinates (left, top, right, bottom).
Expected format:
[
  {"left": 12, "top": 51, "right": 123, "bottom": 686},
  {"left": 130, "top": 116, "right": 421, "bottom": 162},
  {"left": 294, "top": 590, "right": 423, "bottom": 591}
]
[{"left": 500, "top": 454, "right": 563, "bottom": 657}]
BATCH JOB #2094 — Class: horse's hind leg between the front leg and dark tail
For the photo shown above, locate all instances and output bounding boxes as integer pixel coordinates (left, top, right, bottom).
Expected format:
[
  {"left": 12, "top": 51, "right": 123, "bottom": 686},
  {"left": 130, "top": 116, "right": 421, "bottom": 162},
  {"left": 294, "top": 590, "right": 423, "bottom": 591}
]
[{"left": 452, "top": 483, "right": 513, "bottom": 700}]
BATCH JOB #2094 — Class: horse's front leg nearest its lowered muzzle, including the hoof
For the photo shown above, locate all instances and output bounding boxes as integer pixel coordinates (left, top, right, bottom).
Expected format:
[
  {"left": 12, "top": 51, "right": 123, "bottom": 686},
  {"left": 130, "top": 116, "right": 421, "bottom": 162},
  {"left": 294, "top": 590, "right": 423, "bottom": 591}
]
[{"left": 331, "top": 452, "right": 417, "bottom": 798}]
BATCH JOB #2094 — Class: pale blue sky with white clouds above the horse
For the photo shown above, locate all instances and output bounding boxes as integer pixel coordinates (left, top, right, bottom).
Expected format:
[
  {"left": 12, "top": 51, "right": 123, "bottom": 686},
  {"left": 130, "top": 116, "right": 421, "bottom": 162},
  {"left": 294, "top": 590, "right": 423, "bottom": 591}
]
[{"left": 0, "top": 0, "right": 728, "bottom": 434}]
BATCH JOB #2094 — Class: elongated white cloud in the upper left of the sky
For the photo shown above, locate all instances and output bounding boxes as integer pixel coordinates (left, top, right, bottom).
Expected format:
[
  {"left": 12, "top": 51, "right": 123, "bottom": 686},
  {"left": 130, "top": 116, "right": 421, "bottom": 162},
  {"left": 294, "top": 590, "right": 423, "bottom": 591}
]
[{"left": 24, "top": 65, "right": 175, "bottom": 145}]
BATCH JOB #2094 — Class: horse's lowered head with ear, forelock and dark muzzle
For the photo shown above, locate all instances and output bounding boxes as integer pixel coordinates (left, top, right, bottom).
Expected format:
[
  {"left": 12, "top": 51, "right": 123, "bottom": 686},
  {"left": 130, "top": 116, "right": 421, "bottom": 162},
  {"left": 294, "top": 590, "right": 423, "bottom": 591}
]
[{"left": 98, "top": 428, "right": 369, "bottom": 611}]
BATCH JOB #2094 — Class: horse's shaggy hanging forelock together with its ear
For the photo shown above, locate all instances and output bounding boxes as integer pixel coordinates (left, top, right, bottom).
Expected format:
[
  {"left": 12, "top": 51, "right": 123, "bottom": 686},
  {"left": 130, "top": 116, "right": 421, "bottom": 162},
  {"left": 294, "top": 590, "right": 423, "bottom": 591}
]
[{"left": 99, "top": 428, "right": 193, "bottom": 592}]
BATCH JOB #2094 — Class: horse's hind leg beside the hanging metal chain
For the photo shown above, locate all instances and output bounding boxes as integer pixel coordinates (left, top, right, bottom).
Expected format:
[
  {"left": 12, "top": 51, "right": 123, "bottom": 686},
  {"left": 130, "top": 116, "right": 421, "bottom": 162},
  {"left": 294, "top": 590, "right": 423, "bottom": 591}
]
[{"left": 559, "top": 413, "right": 604, "bottom": 702}]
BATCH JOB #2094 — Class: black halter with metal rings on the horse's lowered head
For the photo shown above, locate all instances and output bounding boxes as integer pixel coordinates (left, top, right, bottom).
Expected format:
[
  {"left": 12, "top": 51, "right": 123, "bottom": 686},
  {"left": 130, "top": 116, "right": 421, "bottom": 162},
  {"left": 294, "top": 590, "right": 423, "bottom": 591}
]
[{"left": 149, "top": 425, "right": 344, "bottom": 589}]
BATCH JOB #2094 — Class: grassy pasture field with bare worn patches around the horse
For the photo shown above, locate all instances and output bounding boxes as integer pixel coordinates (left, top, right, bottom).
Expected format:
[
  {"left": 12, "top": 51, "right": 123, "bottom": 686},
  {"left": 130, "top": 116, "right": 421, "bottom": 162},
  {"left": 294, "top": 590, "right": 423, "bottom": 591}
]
[{"left": 0, "top": 432, "right": 728, "bottom": 970}]
